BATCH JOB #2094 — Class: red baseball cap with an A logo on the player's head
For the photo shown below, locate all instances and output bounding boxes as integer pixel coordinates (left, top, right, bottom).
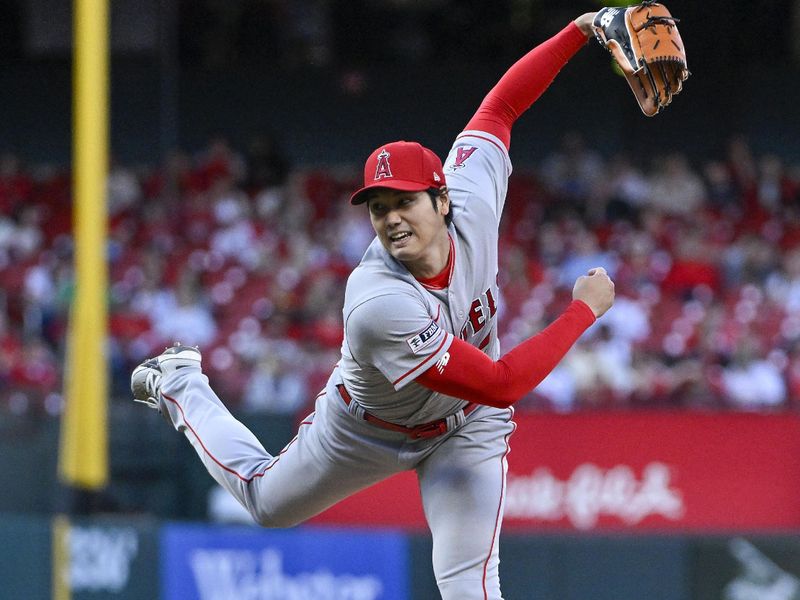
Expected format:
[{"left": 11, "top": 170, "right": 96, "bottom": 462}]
[{"left": 350, "top": 141, "right": 446, "bottom": 204}]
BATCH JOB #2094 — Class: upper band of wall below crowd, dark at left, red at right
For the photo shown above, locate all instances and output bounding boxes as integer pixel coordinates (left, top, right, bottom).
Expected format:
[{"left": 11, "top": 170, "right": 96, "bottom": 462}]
[{"left": 0, "top": 405, "right": 800, "bottom": 534}]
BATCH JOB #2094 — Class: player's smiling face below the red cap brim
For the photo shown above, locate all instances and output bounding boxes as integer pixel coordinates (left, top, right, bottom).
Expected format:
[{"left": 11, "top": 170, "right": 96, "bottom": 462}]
[{"left": 367, "top": 190, "right": 450, "bottom": 277}]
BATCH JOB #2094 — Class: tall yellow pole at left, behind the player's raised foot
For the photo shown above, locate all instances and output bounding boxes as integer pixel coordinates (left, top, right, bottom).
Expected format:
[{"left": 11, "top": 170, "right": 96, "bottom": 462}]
[{"left": 59, "top": 0, "right": 109, "bottom": 490}]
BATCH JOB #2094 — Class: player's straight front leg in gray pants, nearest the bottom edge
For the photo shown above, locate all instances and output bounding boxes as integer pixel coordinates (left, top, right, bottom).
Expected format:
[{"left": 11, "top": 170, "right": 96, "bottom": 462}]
[{"left": 417, "top": 407, "right": 515, "bottom": 600}]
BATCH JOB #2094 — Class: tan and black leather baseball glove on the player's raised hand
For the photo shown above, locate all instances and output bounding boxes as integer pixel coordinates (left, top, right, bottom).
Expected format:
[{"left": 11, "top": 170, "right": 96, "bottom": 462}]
[{"left": 593, "top": 0, "right": 690, "bottom": 117}]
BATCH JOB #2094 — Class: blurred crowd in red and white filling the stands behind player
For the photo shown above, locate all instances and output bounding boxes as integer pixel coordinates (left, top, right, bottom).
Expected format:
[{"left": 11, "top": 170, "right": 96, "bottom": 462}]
[{"left": 0, "top": 133, "right": 800, "bottom": 415}]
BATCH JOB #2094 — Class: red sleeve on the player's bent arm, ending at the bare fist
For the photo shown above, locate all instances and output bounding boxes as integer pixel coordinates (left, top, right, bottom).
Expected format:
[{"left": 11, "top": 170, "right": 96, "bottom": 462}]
[{"left": 416, "top": 300, "right": 595, "bottom": 408}]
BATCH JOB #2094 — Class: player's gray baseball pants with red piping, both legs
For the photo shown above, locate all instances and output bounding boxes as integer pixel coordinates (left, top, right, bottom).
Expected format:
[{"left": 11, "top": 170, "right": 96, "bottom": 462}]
[{"left": 161, "top": 368, "right": 516, "bottom": 600}]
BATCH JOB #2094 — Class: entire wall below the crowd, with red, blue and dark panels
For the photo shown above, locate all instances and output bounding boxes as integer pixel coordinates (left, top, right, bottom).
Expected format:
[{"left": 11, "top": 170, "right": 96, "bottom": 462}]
[{"left": 0, "top": 407, "right": 800, "bottom": 600}]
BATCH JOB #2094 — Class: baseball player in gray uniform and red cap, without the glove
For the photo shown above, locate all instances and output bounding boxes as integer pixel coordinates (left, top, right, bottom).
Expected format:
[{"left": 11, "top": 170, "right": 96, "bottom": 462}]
[{"left": 131, "top": 13, "right": 614, "bottom": 600}]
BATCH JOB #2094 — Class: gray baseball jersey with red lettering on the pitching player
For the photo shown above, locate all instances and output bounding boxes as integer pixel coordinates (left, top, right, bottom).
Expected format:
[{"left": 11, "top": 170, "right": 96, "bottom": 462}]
[{"left": 339, "top": 131, "right": 511, "bottom": 425}]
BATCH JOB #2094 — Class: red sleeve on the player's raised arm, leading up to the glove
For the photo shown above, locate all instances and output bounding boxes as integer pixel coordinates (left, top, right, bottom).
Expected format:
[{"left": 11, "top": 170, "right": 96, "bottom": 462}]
[{"left": 465, "top": 22, "right": 586, "bottom": 148}]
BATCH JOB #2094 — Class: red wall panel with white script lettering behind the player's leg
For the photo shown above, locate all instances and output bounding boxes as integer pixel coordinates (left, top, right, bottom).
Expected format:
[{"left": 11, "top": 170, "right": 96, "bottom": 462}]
[{"left": 314, "top": 411, "right": 800, "bottom": 534}]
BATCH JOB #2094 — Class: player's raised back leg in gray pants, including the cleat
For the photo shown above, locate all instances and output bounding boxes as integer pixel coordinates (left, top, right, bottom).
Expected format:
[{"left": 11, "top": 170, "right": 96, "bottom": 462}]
[{"left": 131, "top": 346, "right": 406, "bottom": 527}]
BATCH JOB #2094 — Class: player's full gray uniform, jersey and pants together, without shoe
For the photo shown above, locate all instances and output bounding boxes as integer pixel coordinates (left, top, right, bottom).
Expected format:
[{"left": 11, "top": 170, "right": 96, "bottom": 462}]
[{"left": 161, "top": 131, "right": 514, "bottom": 600}]
